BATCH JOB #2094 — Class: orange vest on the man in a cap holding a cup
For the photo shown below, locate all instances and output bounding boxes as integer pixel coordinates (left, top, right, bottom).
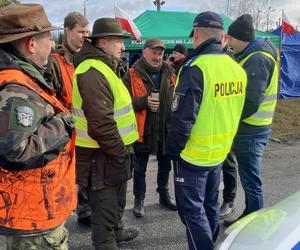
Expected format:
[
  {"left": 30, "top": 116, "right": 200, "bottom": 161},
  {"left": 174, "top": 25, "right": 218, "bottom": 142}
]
[{"left": 129, "top": 68, "right": 176, "bottom": 142}]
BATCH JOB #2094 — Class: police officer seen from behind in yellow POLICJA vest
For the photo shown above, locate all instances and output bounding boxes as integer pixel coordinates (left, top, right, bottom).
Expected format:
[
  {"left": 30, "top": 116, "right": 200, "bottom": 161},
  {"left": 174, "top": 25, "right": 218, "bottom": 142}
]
[{"left": 167, "top": 11, "right": 246, "bottom": 250}]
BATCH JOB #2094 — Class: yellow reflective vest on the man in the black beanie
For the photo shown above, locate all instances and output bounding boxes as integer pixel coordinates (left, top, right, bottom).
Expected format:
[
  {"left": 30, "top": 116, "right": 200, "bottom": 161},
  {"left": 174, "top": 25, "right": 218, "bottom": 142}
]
[{"left": 240, "top": 51, "right": 278, "bottom": 126}]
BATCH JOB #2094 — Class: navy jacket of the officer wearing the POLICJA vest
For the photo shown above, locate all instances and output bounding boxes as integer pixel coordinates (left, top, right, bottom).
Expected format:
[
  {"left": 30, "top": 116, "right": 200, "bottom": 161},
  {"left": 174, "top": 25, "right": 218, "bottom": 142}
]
[{"left": 167, "top": 38, "right": 224, "bottom": 160}]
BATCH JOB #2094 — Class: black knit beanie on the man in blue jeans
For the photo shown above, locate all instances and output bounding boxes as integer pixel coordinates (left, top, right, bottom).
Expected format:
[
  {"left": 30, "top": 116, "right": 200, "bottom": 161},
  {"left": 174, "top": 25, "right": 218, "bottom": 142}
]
[{"left": 228, "top": 14, "right": 255, "bottom": 42}]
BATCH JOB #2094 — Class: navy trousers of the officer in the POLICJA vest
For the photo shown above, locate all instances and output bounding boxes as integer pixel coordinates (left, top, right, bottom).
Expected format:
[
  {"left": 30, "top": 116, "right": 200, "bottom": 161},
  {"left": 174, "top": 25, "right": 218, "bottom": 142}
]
[{"left": 174, "top": 159, "right": 221, "bottom": 250}]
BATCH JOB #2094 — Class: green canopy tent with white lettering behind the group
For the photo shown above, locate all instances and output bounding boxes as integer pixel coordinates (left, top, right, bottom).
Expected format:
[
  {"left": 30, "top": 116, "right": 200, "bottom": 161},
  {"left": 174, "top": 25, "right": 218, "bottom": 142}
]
[{"left": 125, "top": 10, "right": 280, "bottom": 52}]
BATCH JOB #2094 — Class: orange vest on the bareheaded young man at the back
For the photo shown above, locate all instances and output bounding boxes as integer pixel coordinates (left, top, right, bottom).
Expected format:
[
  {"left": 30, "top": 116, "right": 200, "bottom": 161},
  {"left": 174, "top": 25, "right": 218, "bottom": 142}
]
[{"left": 51, "top": 53, "right": 75, "bottom": 110}]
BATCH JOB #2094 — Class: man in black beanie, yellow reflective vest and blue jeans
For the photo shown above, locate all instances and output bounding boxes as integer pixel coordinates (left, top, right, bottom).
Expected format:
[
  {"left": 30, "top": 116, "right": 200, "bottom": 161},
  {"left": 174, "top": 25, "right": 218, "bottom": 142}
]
[{"left": 226, "top": 14, "right": 278, "bottom": 225}]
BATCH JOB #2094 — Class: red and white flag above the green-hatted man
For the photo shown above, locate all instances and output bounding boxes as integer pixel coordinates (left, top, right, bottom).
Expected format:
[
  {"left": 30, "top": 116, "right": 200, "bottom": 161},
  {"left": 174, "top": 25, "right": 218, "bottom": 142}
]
[{"left": 115, "top": 5, "right": 141, "bottom": 42}]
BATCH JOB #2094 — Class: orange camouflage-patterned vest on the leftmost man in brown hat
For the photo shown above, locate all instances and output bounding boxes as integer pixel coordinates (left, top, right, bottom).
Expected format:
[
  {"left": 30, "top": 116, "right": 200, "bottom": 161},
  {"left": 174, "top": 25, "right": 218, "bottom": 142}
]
[{"left": 0, "top": 69, "right": 76, "bottom": 231}]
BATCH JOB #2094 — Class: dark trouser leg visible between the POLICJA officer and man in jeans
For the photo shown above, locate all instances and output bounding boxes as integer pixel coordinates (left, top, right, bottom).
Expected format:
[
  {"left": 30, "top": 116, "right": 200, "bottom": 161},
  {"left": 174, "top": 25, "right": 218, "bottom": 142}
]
[{"left": 222, "top": 151, "right": 238, "bottom": 203}]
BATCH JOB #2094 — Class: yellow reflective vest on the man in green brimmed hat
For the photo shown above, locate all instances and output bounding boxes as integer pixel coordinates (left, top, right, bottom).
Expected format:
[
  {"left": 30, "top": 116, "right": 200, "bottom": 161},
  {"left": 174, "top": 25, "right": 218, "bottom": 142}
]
[{"left": 72, "top": 59, "right": 139, "bottom": 148}]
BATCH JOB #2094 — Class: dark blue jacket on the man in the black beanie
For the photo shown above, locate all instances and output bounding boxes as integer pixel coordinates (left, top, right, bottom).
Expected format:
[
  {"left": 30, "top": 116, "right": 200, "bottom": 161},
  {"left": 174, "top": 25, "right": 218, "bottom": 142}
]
[{"left": 234, "top": 39, "right": 277, "bottom": 134}]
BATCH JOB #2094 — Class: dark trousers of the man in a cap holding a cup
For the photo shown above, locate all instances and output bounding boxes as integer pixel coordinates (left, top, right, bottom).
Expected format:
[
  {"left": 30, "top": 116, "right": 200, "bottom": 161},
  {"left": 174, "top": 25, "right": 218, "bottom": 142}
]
[{"left": 133, "top": 150, "right": 171, "bottom": 200}]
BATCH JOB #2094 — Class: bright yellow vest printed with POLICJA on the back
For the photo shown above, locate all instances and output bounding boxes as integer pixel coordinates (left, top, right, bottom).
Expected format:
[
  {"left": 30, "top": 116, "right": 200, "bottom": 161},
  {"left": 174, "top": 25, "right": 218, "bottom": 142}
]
[{"left": 179, "top": 55, "right": 247, "bottom": 166}]
